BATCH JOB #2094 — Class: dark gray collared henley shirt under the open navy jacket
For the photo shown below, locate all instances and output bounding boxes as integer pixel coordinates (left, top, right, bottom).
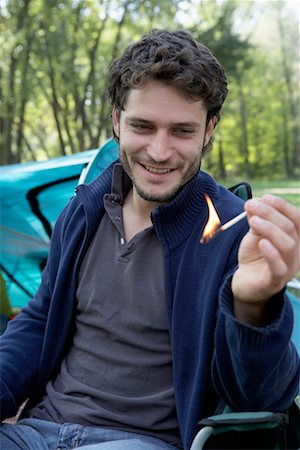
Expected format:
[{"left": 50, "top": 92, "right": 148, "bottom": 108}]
[{"left": 32, "top": 166, "right": 180, "bottom": 443}]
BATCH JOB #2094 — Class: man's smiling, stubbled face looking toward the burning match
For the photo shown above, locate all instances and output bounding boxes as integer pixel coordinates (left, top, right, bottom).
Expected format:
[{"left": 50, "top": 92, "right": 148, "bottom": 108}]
[{"left": 113, "top": 81, "right": 214, "bottom": 204}]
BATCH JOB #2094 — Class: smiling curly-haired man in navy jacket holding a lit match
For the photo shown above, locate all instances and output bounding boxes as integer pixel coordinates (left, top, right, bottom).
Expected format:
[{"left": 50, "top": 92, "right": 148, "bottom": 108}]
[{"left": 0, "top": 31, "right": 300, "bottom": 450}]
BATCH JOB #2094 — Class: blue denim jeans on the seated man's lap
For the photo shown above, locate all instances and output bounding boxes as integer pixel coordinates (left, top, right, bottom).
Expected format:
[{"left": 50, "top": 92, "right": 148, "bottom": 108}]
[{"left": 0, "top": 419, "right": 178, "bottom": 450}]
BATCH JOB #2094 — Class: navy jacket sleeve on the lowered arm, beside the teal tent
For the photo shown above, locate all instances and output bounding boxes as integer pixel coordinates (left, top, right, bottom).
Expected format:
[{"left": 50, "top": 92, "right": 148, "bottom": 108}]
[{"left": 0, "top": 199, "right": 70, "bottom": 420}]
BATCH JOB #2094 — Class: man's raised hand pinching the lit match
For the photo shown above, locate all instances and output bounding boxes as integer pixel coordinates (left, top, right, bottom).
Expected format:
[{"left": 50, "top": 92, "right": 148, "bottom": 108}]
[{"left": 232, "top": 195, "right": 300, "bottom": 326}]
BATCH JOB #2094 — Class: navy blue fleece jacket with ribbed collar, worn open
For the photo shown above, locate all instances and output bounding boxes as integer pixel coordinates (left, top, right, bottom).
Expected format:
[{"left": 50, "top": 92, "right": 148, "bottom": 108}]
[{"left": 0, "top": 165, "right": 299, "bottom": 449}]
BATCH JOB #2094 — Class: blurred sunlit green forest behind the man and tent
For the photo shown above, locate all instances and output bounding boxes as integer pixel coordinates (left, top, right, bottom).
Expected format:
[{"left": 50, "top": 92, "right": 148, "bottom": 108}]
[{"left": 0, "top": 0, "right": 300, "bottom": 180}]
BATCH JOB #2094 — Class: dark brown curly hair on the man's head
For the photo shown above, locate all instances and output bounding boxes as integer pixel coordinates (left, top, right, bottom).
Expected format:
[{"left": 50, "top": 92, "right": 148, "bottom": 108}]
[{"left": 108, "top": 30, "right": 228, "bottom": 150}]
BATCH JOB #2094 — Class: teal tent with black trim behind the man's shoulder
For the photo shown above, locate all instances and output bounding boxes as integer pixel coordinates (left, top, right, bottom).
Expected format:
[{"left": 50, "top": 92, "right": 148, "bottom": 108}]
[{"left": 0, "top": 139, "right": 118, "bottom": 312}]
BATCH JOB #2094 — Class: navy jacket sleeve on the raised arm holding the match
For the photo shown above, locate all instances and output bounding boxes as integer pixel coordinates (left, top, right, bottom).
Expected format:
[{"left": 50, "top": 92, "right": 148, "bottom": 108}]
[{"left": 212, "top": 276, "right": 300, "bottom": 411}]
